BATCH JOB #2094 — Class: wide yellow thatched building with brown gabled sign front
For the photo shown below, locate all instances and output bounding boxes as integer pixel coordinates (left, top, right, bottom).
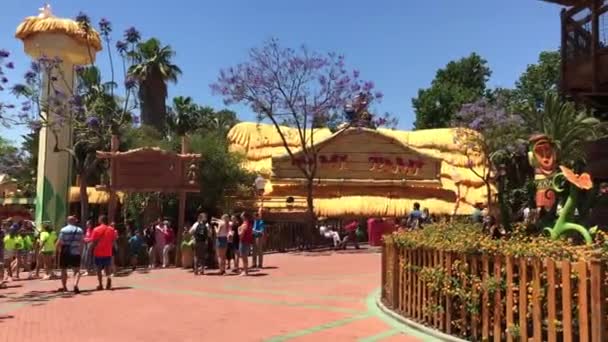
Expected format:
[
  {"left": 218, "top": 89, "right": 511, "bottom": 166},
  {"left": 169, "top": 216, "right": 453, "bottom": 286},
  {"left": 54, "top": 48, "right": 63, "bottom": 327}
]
[{"left": 228, "top": 123, "right": 487, "bottom": 217}]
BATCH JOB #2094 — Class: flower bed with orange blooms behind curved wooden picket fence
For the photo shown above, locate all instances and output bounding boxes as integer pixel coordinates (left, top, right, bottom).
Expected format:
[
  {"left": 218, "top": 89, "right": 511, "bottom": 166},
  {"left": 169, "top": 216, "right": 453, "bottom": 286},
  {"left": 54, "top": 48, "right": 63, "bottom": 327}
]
[{"left": 382, "top": 224, "right": 608, "bottom": 341}]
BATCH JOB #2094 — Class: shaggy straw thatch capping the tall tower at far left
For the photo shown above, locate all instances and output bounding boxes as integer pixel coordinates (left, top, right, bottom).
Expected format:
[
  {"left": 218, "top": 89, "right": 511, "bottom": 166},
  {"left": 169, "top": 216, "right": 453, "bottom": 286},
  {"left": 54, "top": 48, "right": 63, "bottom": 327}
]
[{"left": 15, "top": 16, "right": 102, "bottom": 52}]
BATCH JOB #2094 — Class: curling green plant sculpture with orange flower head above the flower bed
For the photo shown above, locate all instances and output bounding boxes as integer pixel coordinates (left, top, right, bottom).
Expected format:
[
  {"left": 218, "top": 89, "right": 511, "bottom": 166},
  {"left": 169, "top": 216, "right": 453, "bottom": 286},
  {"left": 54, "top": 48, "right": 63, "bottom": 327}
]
[{"left": 545, "top": 166, "right": 597, "bottom": 244}]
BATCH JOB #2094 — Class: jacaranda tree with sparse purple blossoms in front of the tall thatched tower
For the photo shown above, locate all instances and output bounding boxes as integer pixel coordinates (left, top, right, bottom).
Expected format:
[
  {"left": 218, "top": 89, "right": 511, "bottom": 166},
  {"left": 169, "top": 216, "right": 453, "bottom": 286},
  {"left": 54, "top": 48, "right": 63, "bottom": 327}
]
[{"left": 0, "top": 13, "right": 136, "bottom": 219}]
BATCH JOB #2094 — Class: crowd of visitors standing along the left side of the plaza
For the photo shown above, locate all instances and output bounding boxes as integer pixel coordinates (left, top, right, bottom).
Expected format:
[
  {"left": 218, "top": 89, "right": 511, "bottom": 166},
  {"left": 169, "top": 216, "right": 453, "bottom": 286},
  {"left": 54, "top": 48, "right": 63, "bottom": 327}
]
[{"left": 0, "top": 208, "right": 265, "bottom": 293}]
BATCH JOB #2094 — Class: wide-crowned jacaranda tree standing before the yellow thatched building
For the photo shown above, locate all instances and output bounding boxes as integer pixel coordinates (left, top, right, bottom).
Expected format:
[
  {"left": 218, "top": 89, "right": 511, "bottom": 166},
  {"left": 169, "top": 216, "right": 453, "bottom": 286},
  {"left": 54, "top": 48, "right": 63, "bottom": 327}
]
[{"left": 211, "top": 39, "right": 382, "bottom": 230}]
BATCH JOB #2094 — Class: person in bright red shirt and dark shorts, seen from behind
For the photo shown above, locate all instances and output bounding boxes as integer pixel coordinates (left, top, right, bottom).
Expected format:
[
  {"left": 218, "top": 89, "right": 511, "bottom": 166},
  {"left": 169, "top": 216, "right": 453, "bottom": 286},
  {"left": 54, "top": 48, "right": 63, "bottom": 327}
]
[{"left": 91, "top": 215, "right": 118, "bottom": 290}]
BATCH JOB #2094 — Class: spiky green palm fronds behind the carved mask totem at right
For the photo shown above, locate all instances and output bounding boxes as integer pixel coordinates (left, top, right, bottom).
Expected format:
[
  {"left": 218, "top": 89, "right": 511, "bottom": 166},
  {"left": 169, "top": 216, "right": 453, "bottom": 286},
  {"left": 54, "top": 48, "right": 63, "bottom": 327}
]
[{"left": 522, "top": 92, "right": 606, "bottom": 164}]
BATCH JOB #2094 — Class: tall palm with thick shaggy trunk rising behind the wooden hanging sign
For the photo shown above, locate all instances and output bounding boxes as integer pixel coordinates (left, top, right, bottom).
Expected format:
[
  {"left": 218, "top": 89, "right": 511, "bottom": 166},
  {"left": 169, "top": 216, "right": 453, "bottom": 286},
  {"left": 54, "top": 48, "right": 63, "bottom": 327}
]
[{"left": 129, "top": 38, "right": 182, "bottom": 132}]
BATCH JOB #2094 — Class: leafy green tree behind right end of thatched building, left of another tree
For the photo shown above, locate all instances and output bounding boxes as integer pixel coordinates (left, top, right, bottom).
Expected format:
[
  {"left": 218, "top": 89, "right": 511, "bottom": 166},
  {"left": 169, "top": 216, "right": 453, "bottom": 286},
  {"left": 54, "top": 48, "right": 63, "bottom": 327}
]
[{"left": 412, "top": 53, "right": 492, "bottom": 129}]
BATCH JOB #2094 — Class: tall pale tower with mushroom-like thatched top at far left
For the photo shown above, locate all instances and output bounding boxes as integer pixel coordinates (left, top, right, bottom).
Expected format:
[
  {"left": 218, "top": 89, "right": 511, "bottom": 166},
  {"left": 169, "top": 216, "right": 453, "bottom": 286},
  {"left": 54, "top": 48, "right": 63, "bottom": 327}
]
[{"left": 15, "top": 5, "right": 101, "bottom": 227}]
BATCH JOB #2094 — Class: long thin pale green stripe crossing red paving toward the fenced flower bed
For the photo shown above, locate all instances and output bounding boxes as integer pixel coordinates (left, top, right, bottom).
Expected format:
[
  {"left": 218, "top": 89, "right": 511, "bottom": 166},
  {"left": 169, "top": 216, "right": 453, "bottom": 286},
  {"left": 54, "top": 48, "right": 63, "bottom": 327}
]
[{"left": 130, "top": 284, "right": 361, "bottom": 314}]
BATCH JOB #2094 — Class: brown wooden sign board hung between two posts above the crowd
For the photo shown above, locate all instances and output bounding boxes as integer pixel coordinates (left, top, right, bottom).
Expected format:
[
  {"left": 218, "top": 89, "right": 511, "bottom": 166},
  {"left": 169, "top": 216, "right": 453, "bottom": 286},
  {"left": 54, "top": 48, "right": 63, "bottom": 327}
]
[{"left": 97, "top": 136, "right": 201, "bottom": 260}]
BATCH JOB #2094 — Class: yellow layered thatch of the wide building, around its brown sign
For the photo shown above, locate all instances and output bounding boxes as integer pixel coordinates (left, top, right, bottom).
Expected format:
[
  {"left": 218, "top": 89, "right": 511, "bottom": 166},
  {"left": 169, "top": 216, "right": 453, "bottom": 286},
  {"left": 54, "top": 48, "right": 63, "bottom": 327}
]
[{"left": 228, "top": 123, "right": 494, "bottom": 216}]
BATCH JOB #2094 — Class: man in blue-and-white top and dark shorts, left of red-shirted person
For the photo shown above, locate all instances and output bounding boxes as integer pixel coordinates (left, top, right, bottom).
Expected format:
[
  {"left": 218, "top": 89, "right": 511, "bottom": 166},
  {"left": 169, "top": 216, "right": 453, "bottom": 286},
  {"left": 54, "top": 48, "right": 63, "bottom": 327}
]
[{"left": 57, "top": 216, "right": 84, "bottom": 294}]
